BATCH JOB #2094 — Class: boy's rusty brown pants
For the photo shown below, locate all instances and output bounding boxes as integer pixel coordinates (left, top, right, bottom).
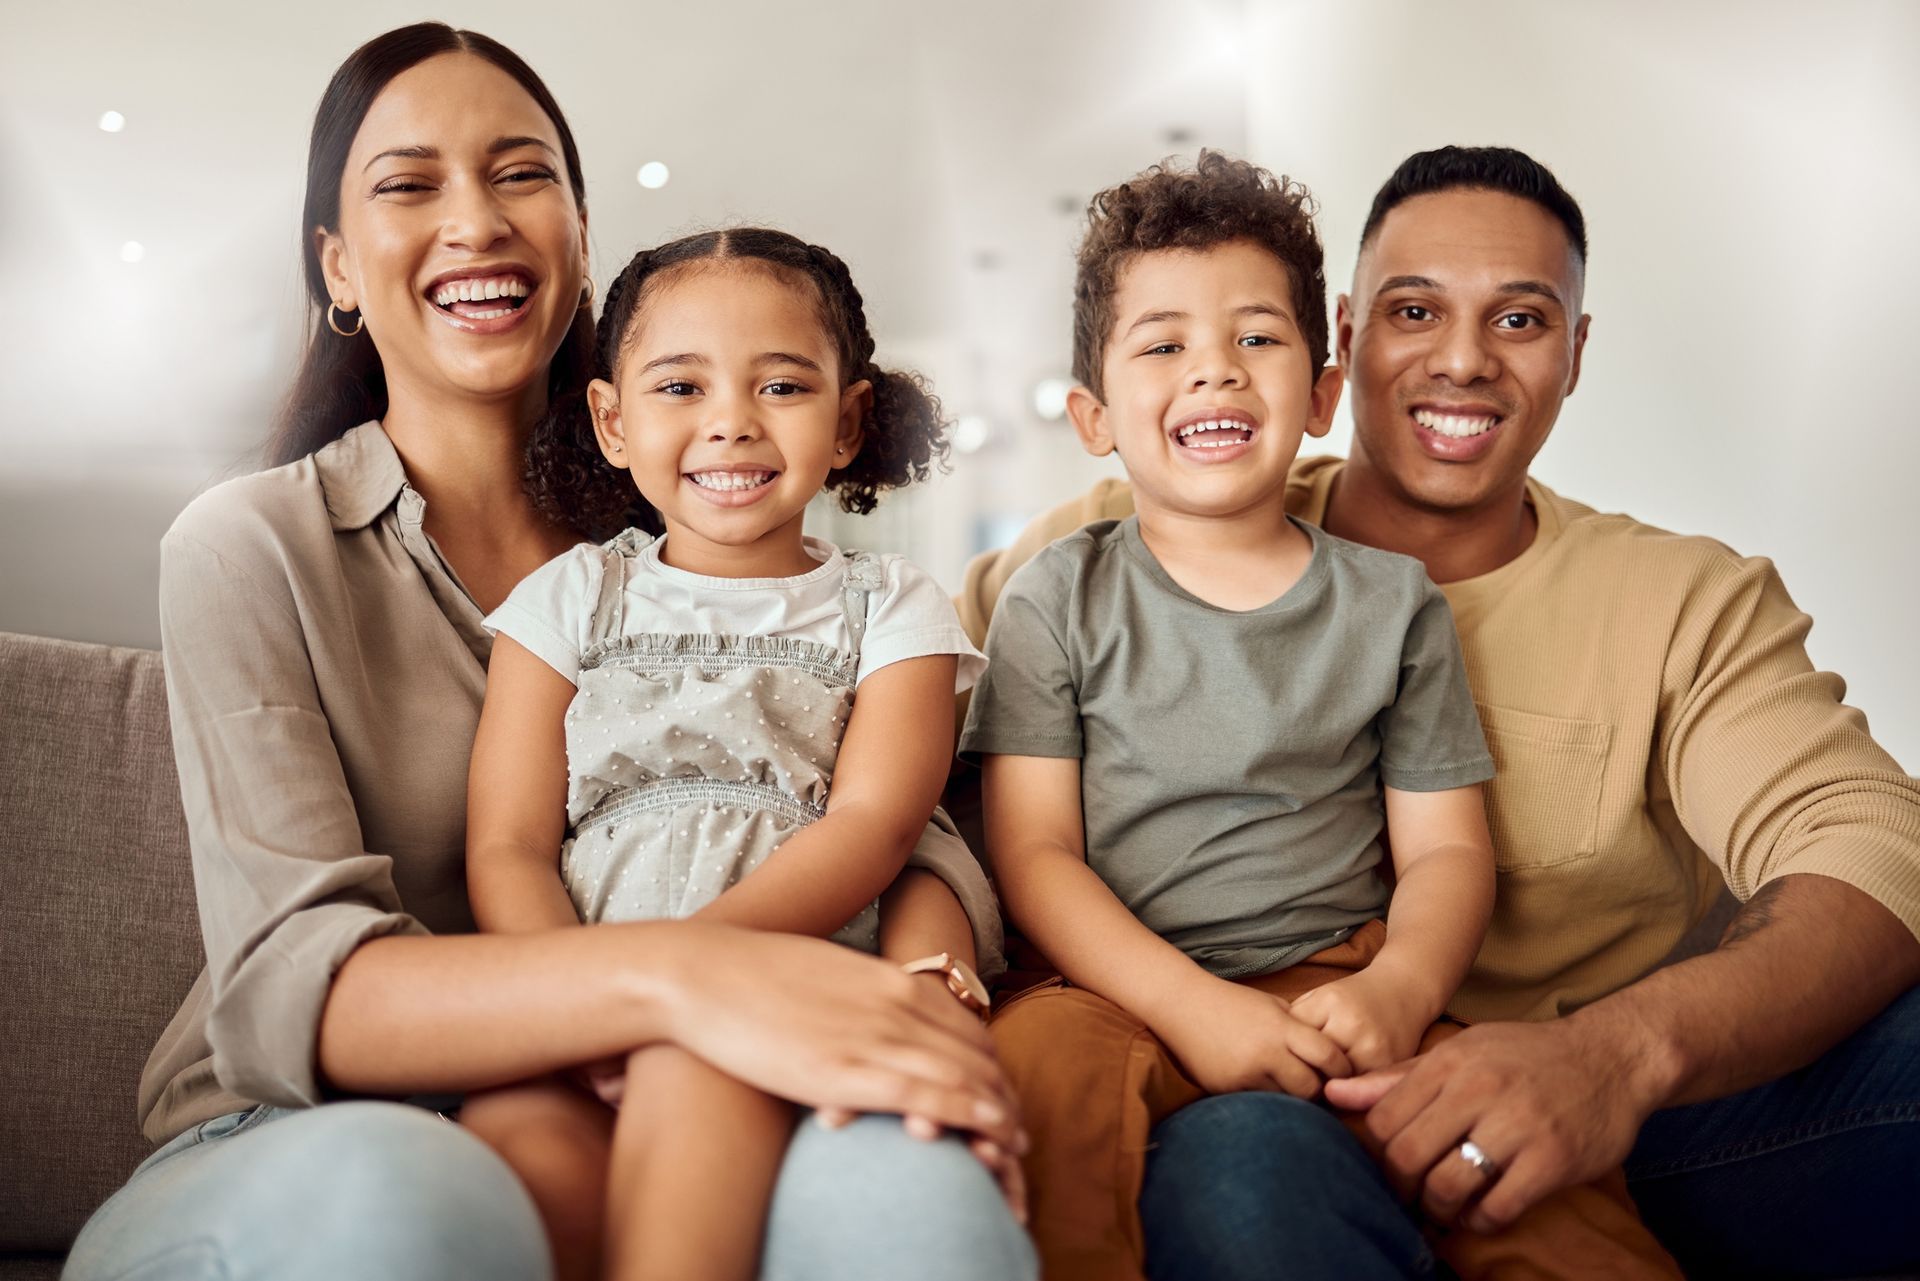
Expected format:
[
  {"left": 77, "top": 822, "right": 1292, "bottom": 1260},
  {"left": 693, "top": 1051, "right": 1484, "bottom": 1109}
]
[{"left": 993, "top": 922, "right": 1680, "bottom": 1281}]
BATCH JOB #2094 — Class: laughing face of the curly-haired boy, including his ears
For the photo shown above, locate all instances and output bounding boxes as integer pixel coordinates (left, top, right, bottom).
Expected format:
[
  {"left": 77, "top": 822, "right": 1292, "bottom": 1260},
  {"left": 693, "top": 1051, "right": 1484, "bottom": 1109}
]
[{"left": 1068, "top": 240, "right": 1340, "bottom": 517}]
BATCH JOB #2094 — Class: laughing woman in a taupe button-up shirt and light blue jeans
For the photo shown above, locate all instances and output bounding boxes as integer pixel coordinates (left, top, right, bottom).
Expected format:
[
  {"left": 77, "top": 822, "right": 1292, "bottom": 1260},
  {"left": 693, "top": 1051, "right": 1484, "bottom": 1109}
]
[{"left": 67, "top": 23, "right": 1033, "bottom": 1279}]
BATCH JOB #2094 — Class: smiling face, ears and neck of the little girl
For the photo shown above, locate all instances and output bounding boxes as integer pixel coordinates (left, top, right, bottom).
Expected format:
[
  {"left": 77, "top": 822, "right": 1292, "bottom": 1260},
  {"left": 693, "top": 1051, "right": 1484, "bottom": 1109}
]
[{"left": 588, "top": 268, "right": 872, "bottom": 578}]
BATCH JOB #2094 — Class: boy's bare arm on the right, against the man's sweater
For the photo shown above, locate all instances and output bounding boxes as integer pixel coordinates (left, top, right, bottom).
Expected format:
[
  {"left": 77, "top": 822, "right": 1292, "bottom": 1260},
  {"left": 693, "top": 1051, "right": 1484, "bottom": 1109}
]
[{"left": 1294, "top": 786, "right": 1494, "bottom": 1072}]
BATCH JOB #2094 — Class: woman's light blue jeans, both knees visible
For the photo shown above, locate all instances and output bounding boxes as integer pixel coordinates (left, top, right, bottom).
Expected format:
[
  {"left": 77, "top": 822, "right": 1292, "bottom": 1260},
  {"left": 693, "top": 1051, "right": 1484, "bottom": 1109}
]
[{"left": 61, "top": 1102, "right": 1039, "bottom": 1281}]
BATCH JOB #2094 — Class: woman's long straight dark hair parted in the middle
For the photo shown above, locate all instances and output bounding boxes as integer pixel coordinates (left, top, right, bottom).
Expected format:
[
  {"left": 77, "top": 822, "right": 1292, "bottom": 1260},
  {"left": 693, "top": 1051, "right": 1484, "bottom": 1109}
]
[{"left": 267, "top": 23, "right": 593, "bottom": 465}]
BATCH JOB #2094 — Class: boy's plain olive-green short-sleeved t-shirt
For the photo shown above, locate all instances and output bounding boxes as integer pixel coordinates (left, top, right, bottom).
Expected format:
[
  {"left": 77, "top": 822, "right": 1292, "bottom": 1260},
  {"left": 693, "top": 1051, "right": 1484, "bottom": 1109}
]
[{"left": 960, "top": 517, "right": 1494, "bottom": 978}]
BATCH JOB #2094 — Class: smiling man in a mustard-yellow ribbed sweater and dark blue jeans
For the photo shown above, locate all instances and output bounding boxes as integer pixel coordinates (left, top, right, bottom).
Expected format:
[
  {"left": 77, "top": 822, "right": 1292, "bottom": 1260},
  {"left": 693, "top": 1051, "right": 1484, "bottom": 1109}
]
[{"left": 962, "top": 148, "right": 1920, "bottom": 1275}]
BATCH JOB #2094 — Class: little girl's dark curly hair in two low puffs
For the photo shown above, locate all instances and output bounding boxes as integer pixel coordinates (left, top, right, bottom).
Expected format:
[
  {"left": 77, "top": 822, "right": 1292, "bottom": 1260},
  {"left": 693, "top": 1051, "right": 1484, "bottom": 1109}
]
[{"left": 528, "top": 227, "right": 947, "bottom": 538}]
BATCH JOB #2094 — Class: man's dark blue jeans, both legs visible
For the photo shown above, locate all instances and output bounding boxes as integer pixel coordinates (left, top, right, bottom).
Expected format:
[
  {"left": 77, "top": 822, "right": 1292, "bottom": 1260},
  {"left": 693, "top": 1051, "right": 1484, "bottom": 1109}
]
[{"left": 1140, "top": 989, "right": 1920, "bottom": 1281}]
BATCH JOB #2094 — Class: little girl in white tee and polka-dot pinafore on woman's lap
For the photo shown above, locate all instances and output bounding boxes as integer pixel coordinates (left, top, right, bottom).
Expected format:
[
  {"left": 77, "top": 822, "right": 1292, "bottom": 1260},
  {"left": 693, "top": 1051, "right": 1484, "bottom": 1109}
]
[{"left": 463, "top": 229, "right": 1018, "bottom": 1279}]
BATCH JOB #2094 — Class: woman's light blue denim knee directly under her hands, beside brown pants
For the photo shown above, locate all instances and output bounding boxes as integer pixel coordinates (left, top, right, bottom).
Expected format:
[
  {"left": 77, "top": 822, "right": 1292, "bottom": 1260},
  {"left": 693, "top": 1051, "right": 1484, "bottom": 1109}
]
[{"left": 766, "top": 1116, "right": 1039, "bottom": 1281}]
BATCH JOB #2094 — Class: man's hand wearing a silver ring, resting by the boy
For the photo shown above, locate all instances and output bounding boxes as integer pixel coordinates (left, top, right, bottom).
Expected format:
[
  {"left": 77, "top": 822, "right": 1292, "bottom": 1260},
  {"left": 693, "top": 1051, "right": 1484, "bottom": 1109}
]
[{"left": 1327, "top": 1020, "right": 1659, "bottom": 1231}]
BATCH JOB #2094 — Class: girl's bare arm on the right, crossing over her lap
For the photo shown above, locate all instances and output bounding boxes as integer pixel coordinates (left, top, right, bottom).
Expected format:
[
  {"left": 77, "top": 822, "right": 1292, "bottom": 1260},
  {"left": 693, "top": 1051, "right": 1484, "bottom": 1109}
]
[{"left": 695, "top": 655, "right": 956, "bottom": 937}]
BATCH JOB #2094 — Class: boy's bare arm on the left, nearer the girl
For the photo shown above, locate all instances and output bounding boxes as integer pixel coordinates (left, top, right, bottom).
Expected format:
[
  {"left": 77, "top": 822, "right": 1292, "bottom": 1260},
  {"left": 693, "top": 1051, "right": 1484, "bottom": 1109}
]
[{"left": 983, "top": 755, "right": 1350, "bottom": 1097}]
